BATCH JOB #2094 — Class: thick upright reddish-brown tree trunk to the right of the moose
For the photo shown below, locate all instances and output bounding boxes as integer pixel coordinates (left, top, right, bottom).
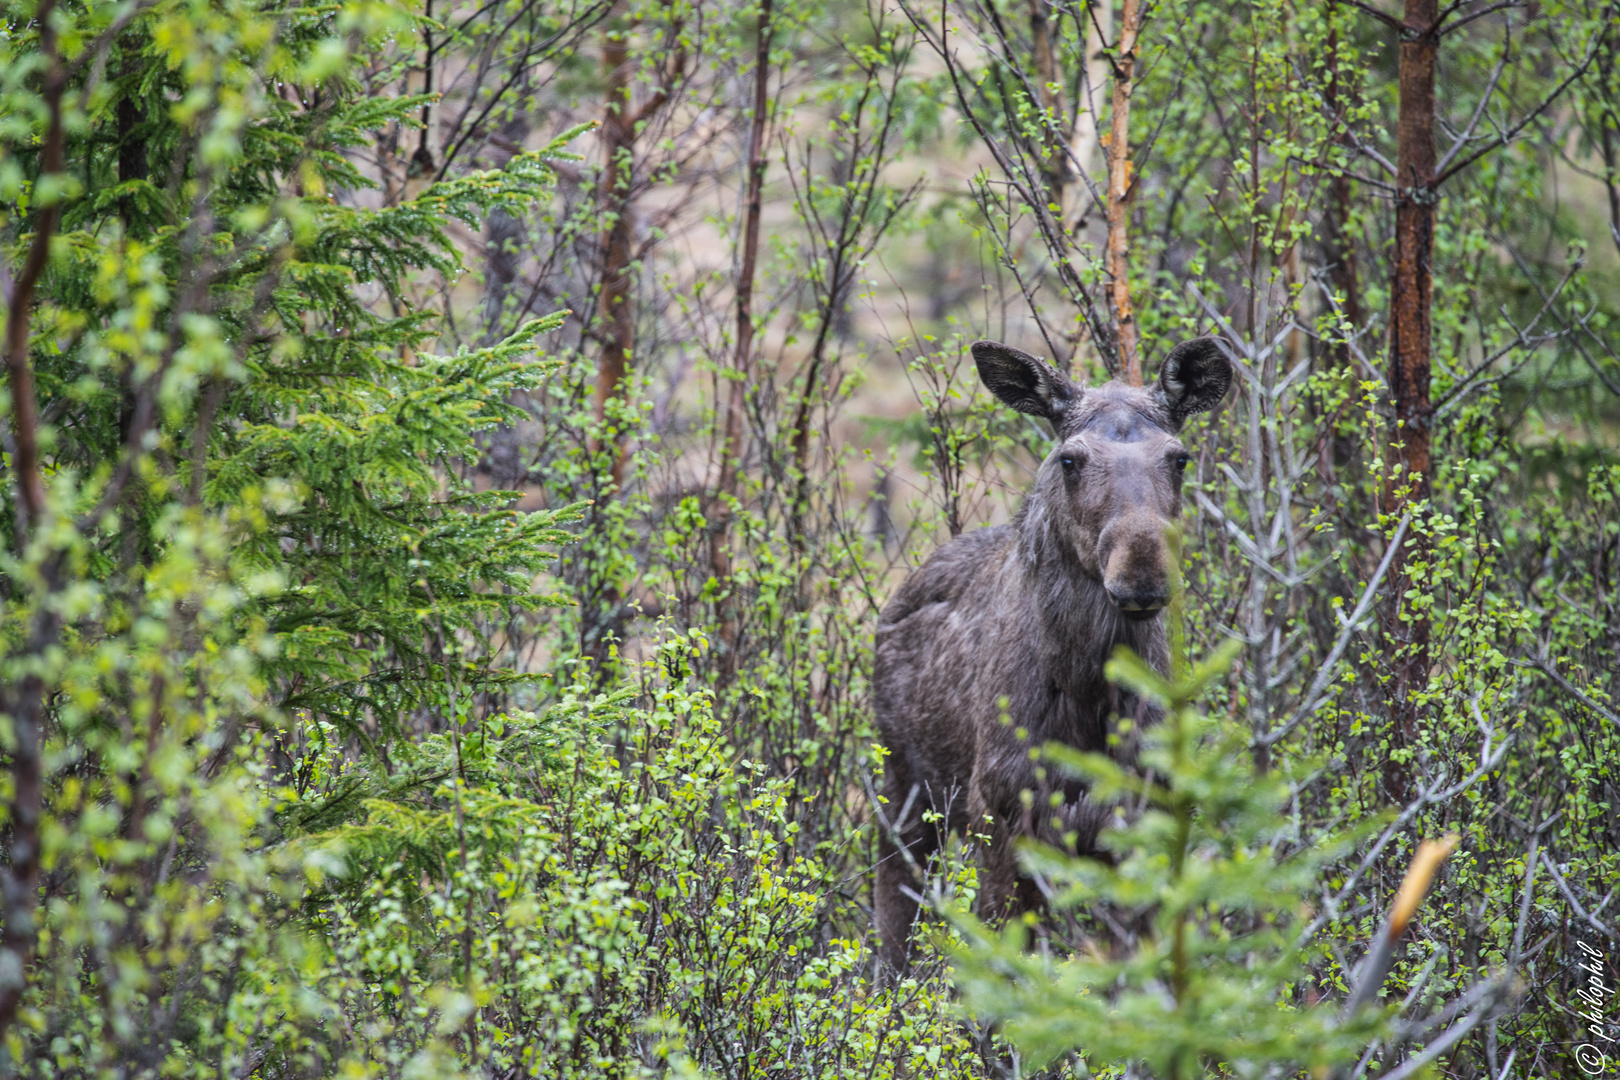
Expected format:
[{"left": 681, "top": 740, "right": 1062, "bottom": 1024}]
[{"left": 1385, "top": 0, "right": 1440, "bottom": 801}]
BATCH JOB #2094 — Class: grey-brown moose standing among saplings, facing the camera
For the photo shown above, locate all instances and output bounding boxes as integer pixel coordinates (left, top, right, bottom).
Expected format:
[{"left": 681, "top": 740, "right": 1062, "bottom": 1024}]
[{"left": 873, "top": 338, "right": 1231, "bottom": 970}]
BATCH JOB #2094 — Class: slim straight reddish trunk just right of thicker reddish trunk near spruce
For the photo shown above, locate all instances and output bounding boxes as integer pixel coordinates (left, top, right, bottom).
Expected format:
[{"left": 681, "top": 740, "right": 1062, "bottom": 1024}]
[{"left": 708, "top": 0, "right": 771, "bottom": 675}]
